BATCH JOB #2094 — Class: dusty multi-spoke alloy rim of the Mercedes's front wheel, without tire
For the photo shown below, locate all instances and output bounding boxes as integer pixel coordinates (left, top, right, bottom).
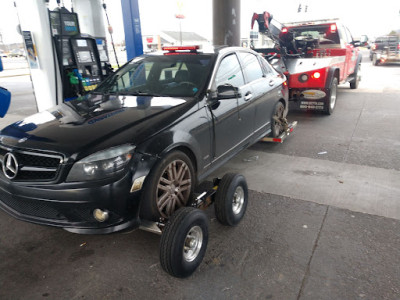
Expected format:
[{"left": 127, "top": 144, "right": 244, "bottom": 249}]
[{"left": 157, "top": 160, "right": 192, "bottom": 218}]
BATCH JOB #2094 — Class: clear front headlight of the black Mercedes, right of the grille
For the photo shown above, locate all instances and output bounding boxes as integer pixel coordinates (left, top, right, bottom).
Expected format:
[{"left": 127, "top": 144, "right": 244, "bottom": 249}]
[{"left": 67, "top": 145, "right": 135, "bottom": 182}]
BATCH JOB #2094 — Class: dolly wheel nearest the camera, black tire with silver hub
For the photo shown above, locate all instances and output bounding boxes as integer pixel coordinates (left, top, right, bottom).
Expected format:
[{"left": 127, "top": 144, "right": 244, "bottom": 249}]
[{"left": 160, "top": 207, "right": 208, "bottom": 278}]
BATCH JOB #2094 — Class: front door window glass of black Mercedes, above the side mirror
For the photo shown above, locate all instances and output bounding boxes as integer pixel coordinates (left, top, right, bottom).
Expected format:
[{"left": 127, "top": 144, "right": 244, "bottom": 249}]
[{"left": 215, "top": 54, "right": 244, "bottom": 87}]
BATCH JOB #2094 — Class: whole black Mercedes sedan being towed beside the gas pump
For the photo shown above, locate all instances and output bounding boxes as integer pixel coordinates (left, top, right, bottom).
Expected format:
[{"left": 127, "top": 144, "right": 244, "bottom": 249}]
[{"left": 0, "top": 46, "right": 288, "bottom": 234}]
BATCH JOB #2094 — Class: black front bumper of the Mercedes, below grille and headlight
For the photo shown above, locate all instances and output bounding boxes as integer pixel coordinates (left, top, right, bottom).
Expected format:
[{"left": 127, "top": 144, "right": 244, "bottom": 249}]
[{"left": 0, "top": 172, "right": 140, "bottom": 234}]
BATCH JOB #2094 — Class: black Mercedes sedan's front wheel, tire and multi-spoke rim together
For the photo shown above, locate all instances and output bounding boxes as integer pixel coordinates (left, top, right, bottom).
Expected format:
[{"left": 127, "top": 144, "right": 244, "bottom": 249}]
[{"left": 140, "top": 151, "right": 195, "bottom": 221}]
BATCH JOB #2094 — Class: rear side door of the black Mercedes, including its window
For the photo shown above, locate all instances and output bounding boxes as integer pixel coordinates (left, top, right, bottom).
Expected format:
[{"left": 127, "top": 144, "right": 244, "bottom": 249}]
[{"left": 239, "top": 52, "right": 282, "bottom": 137}]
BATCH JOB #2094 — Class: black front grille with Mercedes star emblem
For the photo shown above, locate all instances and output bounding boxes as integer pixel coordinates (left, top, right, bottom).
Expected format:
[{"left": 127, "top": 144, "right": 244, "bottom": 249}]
[{"left": 0, "top": 146, "right": 63, "bottom": 181}]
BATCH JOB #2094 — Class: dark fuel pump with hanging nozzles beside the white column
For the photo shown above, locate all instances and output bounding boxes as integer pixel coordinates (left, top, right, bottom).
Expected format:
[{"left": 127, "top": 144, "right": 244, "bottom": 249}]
[{"left": 49, "top": 7, "right": 112, "bottom": 101}]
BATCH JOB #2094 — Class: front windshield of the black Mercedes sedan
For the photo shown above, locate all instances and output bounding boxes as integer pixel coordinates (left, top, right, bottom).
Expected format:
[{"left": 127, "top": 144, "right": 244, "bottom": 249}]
[{"left": 94, "top": 54, "right": 212, "bottom": 97}]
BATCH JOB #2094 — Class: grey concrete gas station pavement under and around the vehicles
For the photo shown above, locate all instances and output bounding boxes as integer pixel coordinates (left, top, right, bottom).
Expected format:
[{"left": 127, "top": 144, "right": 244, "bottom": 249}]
[{"left": 0, "top": 53, "right": 400, "bottom": 299}]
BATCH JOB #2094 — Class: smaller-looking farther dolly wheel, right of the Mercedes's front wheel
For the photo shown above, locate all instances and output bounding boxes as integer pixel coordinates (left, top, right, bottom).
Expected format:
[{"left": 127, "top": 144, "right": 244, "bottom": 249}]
[{"left": 214, "top": 173, "right": 248, "bottom": 226}]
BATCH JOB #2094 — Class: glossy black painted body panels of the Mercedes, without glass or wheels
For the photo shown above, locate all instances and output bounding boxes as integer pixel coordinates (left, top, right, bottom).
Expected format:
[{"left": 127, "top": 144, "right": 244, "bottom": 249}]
[{"left": 0, "top": 50, "right": 287, "bottom": 233}]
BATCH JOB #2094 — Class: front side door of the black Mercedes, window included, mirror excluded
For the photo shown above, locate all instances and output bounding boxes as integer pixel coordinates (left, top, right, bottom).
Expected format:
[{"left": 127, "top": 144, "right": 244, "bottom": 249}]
[{"left": 210, "top": 53, "right": 254, "bottom": 162}]
